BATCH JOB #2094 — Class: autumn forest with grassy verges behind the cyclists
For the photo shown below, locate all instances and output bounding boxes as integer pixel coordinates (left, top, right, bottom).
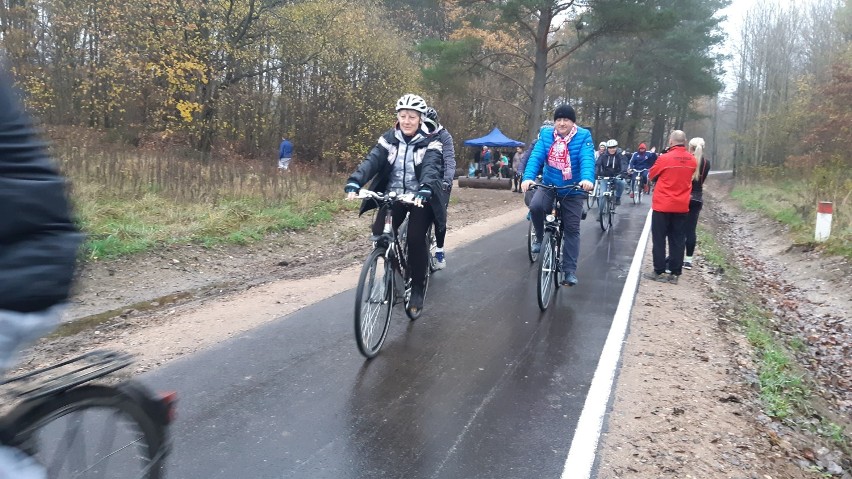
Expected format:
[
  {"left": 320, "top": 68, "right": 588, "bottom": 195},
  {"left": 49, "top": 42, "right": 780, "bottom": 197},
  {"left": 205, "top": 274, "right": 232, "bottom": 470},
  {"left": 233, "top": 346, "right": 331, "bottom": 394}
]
[{"left": 0, "top": 0, "right": 852, "bottom": 259}]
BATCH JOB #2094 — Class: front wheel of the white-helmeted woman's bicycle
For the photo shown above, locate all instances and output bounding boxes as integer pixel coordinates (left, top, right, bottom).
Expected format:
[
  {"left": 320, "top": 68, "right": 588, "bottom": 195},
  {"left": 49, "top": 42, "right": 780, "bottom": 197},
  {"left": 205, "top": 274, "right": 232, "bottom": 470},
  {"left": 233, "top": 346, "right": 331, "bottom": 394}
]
[{"left": 355, "top": 248, "right": 394, "bottom": 359}]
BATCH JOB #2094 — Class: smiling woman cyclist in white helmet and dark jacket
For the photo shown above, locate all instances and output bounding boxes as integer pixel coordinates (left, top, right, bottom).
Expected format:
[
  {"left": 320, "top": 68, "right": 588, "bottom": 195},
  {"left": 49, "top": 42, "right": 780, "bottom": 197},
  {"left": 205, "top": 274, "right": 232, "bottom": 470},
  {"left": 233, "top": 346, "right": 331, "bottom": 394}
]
[{"left": 344, "top": 93, "right": 449, "bottom": 313}]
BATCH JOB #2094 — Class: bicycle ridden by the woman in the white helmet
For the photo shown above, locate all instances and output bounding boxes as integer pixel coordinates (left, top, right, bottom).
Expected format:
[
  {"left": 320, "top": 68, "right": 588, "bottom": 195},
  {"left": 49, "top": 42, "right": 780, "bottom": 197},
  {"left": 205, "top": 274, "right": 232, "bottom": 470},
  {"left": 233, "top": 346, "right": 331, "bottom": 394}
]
[{"left": 355, "top": 188, "right": 431, "bottom": 359}]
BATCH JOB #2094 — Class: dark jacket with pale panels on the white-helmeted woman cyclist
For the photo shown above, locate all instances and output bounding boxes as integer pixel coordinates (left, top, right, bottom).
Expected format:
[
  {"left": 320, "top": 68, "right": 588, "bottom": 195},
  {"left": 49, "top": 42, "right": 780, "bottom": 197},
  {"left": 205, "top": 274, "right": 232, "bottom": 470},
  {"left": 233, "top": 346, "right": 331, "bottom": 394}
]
[{"left": 347, "top": 128, "right": 449, "bottom": 225}]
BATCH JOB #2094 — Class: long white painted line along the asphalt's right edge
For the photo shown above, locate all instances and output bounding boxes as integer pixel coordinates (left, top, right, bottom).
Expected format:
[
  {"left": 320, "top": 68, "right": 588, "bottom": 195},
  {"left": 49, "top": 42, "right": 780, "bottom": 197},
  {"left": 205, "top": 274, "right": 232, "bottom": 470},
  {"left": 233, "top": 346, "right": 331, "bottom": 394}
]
[{"left": 562, "top": 211, "right": 651, "bottom": 479}]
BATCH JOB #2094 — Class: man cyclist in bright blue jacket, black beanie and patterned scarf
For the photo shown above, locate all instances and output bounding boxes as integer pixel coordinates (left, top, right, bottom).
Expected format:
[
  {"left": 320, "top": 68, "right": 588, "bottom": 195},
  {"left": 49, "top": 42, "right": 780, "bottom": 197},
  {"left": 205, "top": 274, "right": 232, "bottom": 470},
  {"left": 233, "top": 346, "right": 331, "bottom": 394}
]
[{"left": 521, "top": 104, "right": 595, "bottom": 286}]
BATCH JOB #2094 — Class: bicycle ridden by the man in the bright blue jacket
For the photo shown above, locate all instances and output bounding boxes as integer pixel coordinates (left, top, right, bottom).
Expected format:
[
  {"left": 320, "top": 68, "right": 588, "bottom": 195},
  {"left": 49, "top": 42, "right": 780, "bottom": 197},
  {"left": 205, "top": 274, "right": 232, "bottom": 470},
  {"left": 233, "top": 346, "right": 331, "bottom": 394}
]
[{"left": 530, "top": 183, "right": 586, "bottom": 311}]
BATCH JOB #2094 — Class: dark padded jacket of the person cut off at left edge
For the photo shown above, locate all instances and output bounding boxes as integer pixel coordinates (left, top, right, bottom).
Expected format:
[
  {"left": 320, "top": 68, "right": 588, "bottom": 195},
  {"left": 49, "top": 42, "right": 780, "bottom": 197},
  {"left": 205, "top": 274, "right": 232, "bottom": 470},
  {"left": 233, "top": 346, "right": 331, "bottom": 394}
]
[{"left": 0, "top": 65, "right": 81, "bottom": 313}]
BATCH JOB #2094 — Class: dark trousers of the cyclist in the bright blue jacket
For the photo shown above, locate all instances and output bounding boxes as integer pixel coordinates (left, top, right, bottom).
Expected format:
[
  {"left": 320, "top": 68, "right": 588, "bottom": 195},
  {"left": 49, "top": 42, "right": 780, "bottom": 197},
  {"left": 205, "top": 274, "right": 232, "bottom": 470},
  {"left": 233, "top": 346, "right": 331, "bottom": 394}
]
[{"left": 530, "top": 189, "right": 584, "bottom": 273}]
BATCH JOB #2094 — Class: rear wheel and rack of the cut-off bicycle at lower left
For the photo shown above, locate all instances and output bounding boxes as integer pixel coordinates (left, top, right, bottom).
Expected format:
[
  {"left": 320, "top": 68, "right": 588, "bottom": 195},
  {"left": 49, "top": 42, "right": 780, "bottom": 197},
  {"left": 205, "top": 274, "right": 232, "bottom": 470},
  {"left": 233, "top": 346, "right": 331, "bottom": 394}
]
[{"left": 0, "top": 351, "right": 176, "bottom": 479}]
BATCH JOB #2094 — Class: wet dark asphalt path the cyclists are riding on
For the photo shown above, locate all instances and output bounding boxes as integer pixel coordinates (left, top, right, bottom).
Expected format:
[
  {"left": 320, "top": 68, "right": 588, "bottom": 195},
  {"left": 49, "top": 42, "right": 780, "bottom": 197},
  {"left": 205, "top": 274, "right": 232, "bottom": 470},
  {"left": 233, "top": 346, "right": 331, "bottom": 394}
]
[{"left": 142, "top": 195, "right": 649, "bottom": 479}]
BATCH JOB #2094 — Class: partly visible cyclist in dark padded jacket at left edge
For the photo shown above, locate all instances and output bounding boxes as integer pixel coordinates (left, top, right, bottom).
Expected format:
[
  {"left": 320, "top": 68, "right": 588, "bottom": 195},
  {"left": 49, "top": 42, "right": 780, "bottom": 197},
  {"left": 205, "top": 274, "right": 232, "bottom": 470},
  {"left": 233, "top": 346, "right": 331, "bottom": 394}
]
[{"left": 0, "top": 53, "right": 81, "bottom": 479}]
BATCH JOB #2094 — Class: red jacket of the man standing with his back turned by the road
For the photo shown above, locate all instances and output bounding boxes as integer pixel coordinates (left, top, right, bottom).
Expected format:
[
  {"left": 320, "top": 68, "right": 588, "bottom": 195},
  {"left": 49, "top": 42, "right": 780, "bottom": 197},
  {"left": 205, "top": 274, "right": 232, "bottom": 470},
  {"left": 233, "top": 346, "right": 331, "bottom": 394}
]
[{"left": 648, "top": 145, "right": 698, "bottom": 213}]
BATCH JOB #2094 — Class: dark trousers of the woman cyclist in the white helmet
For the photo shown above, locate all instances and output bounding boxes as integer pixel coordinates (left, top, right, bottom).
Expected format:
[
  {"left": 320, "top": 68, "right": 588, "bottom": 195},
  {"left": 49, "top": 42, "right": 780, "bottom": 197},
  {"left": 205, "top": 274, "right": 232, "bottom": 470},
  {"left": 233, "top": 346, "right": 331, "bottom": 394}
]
[{"left": 373, "top": 203, "right": 434, "bottom": 283}]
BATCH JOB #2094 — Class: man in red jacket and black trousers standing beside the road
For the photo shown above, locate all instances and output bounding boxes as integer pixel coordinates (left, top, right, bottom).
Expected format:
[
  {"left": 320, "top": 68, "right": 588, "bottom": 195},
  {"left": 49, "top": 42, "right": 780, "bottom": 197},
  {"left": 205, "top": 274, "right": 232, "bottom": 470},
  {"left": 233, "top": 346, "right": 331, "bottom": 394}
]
[{"left": 648, "top": 130, "right": 698, "bottom": 284}]
